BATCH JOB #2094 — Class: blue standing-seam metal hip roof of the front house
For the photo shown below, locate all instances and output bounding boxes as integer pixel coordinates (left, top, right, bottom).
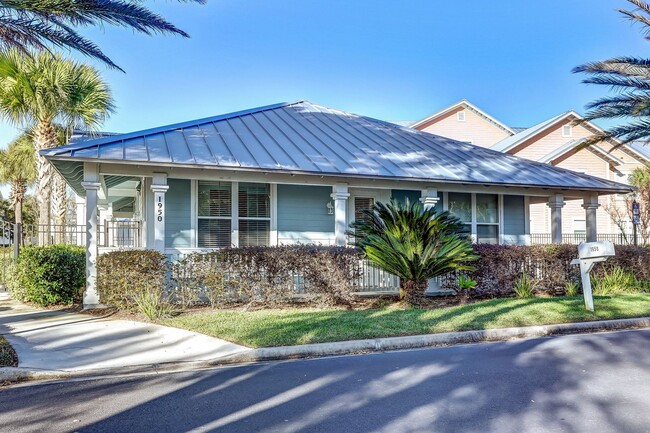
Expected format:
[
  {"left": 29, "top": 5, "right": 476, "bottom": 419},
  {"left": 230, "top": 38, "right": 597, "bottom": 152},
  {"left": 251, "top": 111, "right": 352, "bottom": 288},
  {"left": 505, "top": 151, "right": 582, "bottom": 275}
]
[{"left": 41, "top": 101, "right": 629, "bottom": 192}]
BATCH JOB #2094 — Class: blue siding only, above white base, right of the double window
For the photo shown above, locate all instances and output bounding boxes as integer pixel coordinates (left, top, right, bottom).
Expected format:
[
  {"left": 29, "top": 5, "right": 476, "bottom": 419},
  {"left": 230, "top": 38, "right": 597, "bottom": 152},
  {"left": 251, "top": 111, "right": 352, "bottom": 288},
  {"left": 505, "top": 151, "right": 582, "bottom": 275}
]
[{"left": 278, "top": 185, "right": 334, "bottom": 232}]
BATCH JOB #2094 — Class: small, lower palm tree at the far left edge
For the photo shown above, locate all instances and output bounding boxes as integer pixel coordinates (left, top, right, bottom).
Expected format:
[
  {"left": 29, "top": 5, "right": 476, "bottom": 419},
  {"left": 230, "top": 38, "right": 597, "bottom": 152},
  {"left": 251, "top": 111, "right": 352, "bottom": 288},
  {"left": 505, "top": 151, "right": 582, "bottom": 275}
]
[{"left": 0, "top": 133, "right": 36, "bottom": 224}]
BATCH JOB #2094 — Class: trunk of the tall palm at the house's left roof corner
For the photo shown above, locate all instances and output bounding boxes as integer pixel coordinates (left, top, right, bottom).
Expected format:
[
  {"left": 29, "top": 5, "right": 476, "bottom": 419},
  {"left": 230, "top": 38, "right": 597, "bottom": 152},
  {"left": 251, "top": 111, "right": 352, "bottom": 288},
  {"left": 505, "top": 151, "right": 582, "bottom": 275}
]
[{"left": 34, "top": 121, "right": 57, "bottom": 245}]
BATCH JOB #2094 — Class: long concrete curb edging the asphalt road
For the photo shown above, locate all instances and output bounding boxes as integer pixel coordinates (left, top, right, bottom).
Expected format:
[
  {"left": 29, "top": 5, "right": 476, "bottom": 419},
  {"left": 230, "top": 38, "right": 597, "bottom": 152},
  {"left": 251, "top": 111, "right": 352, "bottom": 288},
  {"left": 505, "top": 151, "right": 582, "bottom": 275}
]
[{"left": 0, "top": 317, "right": 650, "bottom": 386}]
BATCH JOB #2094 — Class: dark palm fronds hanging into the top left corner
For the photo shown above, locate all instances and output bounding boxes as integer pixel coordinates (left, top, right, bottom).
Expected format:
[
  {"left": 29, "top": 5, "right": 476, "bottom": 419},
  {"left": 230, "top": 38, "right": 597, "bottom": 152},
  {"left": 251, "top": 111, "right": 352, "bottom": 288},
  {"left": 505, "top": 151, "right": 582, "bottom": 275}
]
[{"left": 0, "top": 0, "right": 205, "bottom": 69}]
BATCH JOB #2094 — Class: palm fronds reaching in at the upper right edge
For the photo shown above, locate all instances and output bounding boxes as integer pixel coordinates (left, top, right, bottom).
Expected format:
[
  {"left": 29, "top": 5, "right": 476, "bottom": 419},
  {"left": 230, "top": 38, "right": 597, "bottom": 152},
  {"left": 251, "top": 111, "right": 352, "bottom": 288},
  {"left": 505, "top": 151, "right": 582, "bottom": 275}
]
[{"left": 573, "top": 0, "right": 650, "bottom": 146}]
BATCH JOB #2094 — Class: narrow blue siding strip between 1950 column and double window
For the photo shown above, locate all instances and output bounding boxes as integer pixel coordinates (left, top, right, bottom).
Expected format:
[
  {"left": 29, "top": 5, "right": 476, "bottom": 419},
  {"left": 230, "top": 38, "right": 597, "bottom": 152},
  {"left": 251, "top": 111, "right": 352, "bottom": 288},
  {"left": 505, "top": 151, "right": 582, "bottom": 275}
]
[{"left": 165, "top": 179, "right": 192, "bottom": 248}]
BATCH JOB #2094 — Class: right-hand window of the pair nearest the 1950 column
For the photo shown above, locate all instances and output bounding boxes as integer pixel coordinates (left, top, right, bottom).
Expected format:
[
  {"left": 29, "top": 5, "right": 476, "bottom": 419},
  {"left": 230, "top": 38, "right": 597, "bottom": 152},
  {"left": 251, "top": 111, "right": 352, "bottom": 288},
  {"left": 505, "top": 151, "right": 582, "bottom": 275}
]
[{"left": 238, "top": 183, "right": 271, "bottom": 247}]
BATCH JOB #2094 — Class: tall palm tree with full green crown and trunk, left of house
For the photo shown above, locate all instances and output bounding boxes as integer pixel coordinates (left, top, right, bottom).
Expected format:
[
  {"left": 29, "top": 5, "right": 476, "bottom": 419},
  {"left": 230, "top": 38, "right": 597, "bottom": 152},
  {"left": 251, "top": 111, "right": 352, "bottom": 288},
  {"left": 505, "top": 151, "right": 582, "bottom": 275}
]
[{"left": 0, "top": 50, "right": 114, "bottom": 243}]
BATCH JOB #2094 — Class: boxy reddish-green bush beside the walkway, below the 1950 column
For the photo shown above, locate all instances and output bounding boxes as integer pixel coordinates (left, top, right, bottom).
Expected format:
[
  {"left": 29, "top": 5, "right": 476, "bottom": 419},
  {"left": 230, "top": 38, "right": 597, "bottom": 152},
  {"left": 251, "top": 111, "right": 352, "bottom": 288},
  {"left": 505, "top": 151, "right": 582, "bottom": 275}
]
[{"left": 97, "top": 250, "right": 168, "bottom": 317}]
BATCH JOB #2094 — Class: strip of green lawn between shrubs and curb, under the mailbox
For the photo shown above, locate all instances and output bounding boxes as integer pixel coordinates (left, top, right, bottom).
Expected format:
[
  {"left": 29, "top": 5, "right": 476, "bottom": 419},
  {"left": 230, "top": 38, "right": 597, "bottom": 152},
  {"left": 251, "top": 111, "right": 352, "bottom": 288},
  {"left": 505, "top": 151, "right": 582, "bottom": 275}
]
[{"left": 161, "top": 294, "right": 650, "bottom": 347}]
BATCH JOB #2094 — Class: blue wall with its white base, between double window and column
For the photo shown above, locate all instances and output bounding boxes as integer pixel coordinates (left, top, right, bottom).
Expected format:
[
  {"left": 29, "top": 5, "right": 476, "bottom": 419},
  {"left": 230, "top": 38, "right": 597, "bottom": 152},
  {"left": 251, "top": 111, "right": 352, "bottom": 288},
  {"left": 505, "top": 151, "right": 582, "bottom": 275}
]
[{"left": 277, "top": 185, "right": 334, "bottom": 245}]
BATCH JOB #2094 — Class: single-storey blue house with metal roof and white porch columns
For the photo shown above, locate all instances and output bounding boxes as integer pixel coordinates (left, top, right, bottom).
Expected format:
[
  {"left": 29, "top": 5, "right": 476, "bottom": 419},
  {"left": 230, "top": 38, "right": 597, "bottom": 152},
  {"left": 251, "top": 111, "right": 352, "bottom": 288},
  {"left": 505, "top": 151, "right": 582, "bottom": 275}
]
[{"left": 41, "top": 101, "right": 630, "bottom": 305}]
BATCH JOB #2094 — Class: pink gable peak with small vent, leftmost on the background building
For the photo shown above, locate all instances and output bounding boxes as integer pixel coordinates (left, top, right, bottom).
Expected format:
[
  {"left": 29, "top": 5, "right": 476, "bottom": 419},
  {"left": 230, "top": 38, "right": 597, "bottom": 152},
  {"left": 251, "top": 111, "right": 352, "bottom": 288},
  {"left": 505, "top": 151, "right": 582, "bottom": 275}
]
[{"left": 417, "top": 107, "right": 511, "bottom": 147}]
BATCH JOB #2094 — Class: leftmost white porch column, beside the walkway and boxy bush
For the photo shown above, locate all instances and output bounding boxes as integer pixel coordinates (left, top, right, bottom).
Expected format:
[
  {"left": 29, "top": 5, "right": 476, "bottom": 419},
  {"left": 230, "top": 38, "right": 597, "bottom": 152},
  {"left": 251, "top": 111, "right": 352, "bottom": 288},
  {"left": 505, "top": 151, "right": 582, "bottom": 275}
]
[{"left": 81, "top": 179, "right": 101, "bottom": 308}]
